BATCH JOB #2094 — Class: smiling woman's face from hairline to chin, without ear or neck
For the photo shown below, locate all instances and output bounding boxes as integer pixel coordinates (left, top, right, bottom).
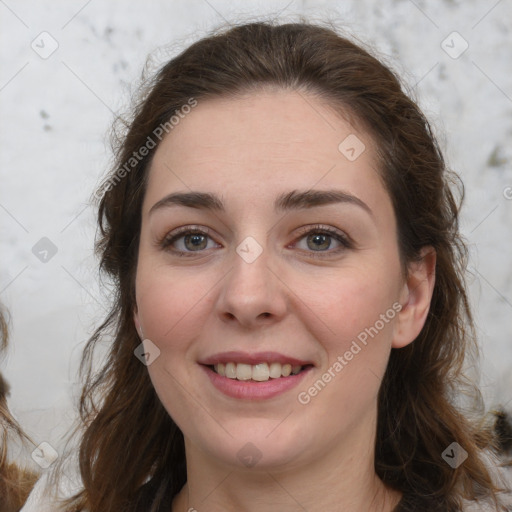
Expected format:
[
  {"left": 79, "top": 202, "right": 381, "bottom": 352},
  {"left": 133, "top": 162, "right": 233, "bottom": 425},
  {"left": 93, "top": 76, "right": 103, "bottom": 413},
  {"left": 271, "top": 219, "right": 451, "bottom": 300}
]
[{"left": 135, "top": 91, "right": 406, "bottom": 468}]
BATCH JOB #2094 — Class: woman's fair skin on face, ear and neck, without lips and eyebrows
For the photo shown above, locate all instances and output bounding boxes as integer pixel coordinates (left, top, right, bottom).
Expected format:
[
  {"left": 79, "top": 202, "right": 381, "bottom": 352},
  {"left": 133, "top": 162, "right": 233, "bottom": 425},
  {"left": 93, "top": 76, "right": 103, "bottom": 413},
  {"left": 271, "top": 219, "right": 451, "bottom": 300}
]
[{"left": 134, "top": 90, "right": 435, "bottom": 512}]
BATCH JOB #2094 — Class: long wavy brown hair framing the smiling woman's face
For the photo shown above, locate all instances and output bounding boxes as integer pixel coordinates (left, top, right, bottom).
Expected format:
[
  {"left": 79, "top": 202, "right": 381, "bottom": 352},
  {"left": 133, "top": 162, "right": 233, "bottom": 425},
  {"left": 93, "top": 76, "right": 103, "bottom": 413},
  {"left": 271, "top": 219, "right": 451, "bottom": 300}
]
[{"left": 60, "top": 22, "right": 508, "bottom": 512}]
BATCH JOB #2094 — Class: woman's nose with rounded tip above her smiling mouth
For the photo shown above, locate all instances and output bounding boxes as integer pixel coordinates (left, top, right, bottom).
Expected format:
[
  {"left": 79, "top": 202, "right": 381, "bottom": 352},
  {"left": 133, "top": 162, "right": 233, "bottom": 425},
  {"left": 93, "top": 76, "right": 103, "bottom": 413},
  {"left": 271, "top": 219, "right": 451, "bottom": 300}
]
[{"left": 217, "top": 243, "right": 288, "bottom": 328}]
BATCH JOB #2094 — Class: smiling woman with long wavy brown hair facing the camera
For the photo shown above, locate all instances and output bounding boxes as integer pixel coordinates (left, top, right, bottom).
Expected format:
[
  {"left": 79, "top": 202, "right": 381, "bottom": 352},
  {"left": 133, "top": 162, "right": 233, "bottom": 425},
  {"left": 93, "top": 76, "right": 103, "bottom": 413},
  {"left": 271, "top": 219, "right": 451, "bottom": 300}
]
[{"left": 23, "top": 19, "right": 505, "bottom": 512}]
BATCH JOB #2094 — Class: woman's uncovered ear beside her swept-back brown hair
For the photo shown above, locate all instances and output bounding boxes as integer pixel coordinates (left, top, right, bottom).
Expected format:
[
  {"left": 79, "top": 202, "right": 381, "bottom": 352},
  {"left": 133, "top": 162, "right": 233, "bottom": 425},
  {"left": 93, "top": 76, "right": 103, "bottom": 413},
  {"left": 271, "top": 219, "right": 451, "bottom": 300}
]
[{"left": 391, "top": 246, "right": 436, "bottom": 348}]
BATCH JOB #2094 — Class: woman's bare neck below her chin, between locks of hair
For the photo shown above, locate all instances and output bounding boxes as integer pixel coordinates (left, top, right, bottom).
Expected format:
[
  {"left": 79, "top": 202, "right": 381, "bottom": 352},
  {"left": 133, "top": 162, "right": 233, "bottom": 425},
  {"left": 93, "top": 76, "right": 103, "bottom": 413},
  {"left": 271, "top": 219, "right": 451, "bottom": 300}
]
[{"left": 172, "top": 414, "right": 401, "bottom": 512}]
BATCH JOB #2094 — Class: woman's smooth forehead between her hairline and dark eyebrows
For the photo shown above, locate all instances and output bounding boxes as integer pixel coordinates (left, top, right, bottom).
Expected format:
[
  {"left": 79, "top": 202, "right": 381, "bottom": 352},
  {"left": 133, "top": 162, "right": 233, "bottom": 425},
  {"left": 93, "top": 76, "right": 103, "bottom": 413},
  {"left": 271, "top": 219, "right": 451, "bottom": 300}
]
[{"left": 146, "top": 90, "right": 389, "bottom": 218}]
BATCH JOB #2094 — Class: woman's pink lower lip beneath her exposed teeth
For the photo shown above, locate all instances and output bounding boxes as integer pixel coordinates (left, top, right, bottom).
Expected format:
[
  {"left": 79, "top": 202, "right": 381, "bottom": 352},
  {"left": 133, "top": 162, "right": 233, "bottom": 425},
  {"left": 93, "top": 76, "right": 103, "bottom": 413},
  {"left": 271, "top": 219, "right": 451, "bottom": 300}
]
[{"left": 201, "top": 365, "right": 312, "bottom": 400}]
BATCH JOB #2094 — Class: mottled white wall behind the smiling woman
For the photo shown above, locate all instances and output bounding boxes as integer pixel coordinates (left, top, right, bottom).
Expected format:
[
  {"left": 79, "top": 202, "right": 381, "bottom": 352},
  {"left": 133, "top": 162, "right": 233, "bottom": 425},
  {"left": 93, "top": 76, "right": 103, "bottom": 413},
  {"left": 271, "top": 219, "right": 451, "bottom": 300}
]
[{"left": 0, "top": 0, "right": 512, "bottom": 458}]
